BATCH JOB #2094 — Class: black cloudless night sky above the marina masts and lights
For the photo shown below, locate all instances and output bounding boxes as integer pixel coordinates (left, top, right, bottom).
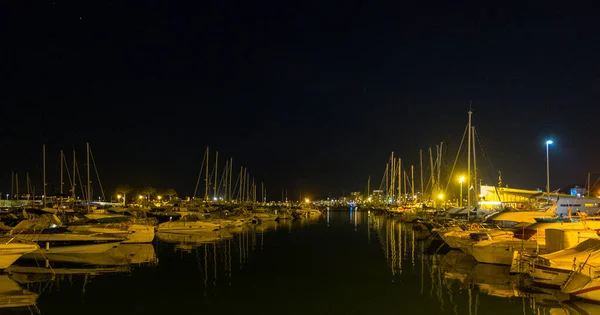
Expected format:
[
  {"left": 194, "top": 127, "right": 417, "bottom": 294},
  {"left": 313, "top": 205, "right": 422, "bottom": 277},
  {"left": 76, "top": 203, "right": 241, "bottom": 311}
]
[{"left": 0, "top": 0, "right": 600, "bottom": 198}]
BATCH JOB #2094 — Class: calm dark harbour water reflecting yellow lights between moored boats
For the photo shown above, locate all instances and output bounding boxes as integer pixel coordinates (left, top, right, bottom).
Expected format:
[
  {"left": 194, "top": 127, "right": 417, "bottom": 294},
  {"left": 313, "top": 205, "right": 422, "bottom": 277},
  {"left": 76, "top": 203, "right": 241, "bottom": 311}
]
[{"left": 0, "top": 211, "right": 600, "bottom": 315}]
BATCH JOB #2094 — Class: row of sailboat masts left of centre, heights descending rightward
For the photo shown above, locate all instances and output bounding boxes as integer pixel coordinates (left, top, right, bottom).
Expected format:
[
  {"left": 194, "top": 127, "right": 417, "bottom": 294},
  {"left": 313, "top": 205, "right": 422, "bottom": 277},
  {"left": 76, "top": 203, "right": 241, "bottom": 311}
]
[{"left": 194, "top": 147, "right": 267, "bottom": 203}]
